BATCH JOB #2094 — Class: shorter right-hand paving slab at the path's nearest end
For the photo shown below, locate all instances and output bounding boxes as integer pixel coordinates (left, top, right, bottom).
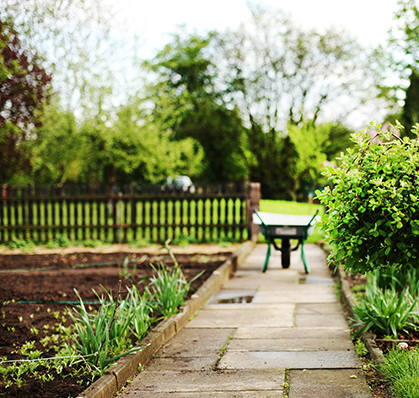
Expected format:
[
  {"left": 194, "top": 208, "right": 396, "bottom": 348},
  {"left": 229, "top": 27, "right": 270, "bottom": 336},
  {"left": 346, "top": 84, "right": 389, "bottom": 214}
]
[{"left": 288, "top": 369, "right": 373, "bottom": 398}]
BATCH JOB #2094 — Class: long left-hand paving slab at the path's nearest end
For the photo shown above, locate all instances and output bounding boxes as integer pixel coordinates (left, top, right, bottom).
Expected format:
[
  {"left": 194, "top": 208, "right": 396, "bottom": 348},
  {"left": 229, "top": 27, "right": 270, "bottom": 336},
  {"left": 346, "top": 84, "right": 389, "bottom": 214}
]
[{"left": 120, "top": 369, "right": 285, "bottom": 397}]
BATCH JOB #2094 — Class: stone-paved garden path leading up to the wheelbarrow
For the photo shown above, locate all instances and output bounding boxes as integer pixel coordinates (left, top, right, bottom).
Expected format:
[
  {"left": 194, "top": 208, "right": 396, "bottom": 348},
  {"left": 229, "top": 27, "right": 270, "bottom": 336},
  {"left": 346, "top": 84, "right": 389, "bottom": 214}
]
[{"left": 119, "top": 245, "right": 372, "bottom": 398}]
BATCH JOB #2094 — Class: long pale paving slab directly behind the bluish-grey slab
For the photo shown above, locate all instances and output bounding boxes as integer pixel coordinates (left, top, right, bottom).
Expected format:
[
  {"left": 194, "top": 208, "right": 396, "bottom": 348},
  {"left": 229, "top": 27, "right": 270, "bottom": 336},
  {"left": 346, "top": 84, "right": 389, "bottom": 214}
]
[{"left": 228, "top": 337, "right": 354, "bottom": 352}]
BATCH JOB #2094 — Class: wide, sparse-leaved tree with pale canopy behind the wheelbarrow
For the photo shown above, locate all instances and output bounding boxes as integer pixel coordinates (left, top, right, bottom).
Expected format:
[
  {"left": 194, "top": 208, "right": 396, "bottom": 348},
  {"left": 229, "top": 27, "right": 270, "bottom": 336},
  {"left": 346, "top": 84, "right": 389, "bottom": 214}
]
[{"left": 213, "top": 6, "right": 384, "bottom": 198}]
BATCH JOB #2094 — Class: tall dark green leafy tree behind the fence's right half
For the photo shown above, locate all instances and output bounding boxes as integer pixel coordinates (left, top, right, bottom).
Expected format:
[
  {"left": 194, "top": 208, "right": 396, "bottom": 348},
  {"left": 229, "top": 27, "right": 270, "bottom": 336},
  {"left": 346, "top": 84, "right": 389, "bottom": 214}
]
[{"left": 147, "top": 35, "right": 251, "bottom": 182}]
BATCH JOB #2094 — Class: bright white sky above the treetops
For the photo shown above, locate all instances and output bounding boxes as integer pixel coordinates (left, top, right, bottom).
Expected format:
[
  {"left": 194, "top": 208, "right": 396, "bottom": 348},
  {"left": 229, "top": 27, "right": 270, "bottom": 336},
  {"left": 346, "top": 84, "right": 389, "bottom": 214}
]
[{"left": 120, "top": 0, "right": 397, "bottom": 54}]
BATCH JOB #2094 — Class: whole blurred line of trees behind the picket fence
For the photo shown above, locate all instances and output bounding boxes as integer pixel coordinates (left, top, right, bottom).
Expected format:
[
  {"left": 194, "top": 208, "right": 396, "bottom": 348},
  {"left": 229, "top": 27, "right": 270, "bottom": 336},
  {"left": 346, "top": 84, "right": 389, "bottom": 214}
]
[{"left": 0, "top": 0, "right": 419, "bottom": 199}]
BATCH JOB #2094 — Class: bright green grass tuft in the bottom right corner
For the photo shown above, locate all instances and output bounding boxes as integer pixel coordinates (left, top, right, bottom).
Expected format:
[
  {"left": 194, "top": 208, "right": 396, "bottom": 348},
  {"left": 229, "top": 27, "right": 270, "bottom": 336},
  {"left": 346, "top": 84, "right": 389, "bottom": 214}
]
[{"left": 380, "top": 349, "right": 419, "bottom": 398}]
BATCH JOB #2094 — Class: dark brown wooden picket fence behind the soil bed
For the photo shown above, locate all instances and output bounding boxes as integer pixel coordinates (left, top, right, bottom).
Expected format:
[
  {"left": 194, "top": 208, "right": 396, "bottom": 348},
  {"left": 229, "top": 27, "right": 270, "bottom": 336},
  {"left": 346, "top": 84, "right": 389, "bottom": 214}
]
[{"left": 0, "top": 183, "right": 260, "bottom": 243}]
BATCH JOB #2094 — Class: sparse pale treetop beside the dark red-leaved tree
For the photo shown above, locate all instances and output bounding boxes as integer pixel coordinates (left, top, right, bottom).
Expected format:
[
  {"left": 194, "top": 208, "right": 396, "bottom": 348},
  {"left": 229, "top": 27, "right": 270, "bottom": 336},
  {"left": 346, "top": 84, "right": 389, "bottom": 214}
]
[{"left": 0, "top": 0, "right": 131, "bottom": 119}]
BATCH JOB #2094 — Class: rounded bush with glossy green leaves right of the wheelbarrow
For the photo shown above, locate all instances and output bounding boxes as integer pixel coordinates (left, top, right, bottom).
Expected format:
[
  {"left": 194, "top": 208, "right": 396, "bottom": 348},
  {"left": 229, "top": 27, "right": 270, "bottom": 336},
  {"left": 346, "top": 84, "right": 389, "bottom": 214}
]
[{"left": 318, "top": 123, "right": 419, "bottom": 273}]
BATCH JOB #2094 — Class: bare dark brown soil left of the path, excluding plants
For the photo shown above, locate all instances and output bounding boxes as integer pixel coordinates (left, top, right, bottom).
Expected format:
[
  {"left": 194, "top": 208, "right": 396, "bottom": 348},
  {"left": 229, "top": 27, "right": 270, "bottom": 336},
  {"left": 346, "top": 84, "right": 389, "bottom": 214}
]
[{"left": 0, "top": 250, "right": 231, "bottom": 398}]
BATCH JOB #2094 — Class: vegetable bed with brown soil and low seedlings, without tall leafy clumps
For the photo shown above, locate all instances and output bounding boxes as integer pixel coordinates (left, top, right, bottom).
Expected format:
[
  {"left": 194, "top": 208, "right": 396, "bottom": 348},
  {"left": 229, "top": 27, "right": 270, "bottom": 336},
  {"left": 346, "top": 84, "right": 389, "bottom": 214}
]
[{"left": 0, "top": 251, "right": 231, "bottom": 398}]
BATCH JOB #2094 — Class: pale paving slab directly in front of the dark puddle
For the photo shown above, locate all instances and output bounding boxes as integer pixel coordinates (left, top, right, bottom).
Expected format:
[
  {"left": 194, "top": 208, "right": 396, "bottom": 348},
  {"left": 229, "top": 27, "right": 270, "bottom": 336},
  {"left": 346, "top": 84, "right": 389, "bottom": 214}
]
[{"left": 185, "top": 304, "right": 295, "bottom": 328}]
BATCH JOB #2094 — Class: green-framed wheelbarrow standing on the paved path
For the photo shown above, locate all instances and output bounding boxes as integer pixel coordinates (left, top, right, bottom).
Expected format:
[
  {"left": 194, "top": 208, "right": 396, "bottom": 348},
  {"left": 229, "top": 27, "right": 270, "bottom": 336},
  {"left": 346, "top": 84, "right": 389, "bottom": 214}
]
[{"left": 253, "top": 210, "right": 319, "bottom": 274}]
